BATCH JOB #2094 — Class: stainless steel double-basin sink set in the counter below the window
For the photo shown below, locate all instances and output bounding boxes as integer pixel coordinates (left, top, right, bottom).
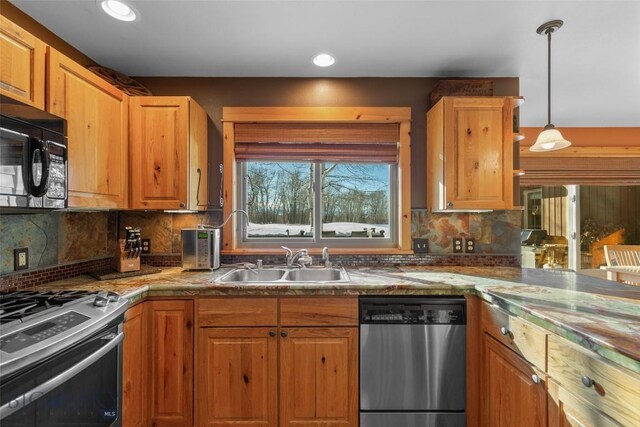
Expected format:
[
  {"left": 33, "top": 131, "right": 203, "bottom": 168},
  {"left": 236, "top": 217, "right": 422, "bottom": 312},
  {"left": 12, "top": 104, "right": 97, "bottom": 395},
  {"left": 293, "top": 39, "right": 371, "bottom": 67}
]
[{"left": 214, "top": 267, "right": 350, "bottom": 284}]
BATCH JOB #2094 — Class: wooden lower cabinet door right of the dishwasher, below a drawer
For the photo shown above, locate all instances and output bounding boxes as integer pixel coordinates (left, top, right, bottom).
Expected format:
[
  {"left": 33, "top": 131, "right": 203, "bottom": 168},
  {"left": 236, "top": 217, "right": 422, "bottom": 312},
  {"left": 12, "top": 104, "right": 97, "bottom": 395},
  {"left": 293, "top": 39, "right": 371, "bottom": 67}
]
[{"left": 480, "top": 333, "right": 547, "bottom": 427}]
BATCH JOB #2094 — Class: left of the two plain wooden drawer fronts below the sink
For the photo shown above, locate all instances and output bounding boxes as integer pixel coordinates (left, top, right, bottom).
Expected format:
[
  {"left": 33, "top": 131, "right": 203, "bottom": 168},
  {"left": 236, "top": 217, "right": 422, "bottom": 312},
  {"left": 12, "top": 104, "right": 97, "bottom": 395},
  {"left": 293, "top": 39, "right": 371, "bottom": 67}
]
[{"left": 198, "top": 297, "right": 278, "bottom": 327}]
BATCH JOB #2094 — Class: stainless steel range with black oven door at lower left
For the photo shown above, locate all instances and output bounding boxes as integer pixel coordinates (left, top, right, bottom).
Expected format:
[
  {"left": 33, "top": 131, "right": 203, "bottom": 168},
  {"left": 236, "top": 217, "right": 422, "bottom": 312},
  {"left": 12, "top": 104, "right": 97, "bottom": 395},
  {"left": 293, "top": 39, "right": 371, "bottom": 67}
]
[{"left": 0, "top": 291, "right": 128, "bottom": 427}]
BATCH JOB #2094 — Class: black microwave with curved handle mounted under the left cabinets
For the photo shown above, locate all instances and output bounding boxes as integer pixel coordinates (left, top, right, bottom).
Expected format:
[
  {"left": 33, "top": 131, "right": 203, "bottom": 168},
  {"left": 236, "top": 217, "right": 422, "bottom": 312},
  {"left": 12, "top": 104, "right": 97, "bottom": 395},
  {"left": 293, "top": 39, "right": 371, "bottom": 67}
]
[{"left": 0, "top": 95, "right": 68, "bottom": 209}]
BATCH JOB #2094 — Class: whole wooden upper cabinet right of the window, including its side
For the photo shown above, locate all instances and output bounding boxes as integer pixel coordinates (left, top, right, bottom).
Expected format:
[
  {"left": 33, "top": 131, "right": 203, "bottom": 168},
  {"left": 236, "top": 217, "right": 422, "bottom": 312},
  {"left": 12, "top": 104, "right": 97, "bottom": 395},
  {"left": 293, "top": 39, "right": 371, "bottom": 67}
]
[{"left": 427, "top": 97, "right": 515, "bottom": 211}]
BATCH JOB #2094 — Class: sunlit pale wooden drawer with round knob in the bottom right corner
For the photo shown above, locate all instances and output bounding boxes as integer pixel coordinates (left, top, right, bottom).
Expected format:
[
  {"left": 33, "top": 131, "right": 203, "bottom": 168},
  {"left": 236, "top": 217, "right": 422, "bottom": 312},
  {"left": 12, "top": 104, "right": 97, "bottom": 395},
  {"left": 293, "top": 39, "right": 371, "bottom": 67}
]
[{"left": 548, "top": 335, "right": 640, "bottom": 426}]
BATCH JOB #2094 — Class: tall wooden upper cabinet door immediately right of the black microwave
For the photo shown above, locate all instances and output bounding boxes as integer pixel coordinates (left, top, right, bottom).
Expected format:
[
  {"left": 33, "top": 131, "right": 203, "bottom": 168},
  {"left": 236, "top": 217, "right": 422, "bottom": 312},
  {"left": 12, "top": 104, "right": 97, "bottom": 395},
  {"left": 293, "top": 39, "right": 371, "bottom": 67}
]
[{"left": 47, "top": 47, "right": 128, "bottom": 208}]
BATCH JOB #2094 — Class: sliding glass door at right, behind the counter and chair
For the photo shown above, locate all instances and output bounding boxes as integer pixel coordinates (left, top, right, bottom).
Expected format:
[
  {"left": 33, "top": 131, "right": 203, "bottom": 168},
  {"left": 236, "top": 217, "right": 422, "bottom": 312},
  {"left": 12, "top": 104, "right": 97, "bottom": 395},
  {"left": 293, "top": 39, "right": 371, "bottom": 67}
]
[{"left": 521, "top": 185, "right": 640, "bottom": 272}]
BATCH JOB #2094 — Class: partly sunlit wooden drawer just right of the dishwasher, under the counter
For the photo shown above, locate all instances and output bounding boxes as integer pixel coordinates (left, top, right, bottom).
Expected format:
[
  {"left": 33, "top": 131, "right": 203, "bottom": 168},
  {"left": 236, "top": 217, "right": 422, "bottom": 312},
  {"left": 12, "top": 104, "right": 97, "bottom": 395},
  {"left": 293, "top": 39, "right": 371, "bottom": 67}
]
[{"left": 481, "top": 303, "right": 547, "bottom": 370}]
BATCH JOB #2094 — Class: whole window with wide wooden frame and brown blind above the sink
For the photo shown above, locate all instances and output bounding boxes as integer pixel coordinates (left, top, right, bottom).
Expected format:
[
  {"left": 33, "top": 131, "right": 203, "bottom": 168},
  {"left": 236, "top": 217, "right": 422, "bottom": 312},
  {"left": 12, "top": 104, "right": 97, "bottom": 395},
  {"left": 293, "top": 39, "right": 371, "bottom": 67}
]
[{"left": 222, "top": 107, "right": 411, "bottom": 253}]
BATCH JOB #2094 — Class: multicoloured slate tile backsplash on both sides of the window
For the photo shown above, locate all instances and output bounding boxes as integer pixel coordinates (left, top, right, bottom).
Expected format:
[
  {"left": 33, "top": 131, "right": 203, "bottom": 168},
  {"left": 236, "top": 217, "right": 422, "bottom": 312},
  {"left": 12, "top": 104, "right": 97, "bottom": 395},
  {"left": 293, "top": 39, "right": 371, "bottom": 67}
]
[{"left": 0, "top": 209, "right": 522, "bottom": 281}]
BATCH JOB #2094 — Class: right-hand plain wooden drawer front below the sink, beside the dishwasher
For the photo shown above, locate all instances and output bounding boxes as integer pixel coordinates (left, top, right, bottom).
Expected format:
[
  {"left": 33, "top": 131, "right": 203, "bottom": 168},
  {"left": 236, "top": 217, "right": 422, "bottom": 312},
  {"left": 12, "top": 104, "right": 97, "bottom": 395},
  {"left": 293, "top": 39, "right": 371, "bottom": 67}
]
[{"left": 280, "top": 297, "right": 358, "bottom": 326}]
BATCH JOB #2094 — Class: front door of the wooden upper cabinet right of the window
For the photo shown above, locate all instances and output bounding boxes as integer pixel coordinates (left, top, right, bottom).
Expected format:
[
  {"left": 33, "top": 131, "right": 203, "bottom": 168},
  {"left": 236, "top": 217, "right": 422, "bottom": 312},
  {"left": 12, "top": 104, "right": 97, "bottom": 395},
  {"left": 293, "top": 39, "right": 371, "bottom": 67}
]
[{"left": 444, "top": 98, "right": 513, "bottom": 209}]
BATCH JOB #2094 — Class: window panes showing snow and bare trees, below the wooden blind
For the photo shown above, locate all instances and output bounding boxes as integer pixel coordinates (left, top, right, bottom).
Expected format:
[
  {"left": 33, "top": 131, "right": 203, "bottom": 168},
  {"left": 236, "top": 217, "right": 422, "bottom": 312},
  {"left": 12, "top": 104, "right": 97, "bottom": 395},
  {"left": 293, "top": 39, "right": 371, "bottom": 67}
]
[{"left": 237, "top": 161, "right": 397, "bottom": 247}]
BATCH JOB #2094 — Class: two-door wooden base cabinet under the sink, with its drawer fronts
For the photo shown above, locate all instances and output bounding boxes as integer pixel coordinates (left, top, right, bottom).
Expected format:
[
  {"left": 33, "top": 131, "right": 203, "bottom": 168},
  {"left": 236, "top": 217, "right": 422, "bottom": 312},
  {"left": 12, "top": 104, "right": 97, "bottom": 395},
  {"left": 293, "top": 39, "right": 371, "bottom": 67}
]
[{"left": 196, "top": 297, "right": 358, "bottom": 427}]
